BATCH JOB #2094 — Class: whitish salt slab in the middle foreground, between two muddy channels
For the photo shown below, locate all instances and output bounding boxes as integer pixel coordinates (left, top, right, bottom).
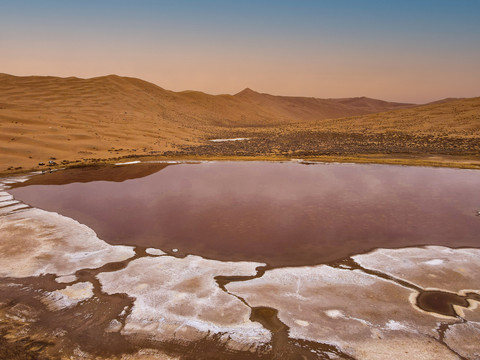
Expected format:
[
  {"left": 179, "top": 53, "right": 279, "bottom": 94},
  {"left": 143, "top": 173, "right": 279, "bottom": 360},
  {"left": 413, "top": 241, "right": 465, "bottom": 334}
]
[{"left": 97, "top": 255, "right": 271, "bottom": 346}]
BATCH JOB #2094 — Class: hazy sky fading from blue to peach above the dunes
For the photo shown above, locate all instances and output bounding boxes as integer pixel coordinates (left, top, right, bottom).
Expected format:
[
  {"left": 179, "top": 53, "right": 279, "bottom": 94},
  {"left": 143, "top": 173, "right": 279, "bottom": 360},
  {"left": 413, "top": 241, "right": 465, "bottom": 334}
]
[{"left": 0, "top": 0, "right": 480, "bottom": 103}]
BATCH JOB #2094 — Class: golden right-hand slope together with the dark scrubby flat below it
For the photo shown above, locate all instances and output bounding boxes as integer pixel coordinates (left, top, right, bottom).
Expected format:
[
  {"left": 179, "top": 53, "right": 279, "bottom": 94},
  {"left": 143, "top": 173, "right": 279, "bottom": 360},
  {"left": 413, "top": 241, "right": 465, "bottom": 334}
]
[{"left": 176, "top": 98, "right": 480, "bottom": 168}]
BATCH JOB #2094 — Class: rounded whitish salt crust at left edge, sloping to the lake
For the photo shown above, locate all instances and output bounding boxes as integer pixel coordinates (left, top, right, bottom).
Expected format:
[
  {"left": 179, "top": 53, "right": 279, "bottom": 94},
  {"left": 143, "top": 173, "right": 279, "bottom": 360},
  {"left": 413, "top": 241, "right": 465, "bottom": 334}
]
[{"left": 0, "top": 208, "right": 135, "bottom": 277}]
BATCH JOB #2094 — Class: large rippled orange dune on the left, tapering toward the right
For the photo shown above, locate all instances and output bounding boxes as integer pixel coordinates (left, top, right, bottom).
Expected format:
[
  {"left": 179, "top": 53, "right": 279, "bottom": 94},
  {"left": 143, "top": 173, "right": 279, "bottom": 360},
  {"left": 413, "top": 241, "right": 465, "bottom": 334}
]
[{"left": 0, "top": 74, "right": 412, "bottom": 171}]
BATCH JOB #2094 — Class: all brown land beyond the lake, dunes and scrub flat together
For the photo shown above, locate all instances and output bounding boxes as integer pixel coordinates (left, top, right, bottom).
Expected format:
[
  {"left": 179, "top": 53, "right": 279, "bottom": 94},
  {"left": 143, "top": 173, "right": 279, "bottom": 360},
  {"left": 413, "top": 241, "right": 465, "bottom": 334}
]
[{"left": 0, "top": 74, "right": 480, "bottom": 173}]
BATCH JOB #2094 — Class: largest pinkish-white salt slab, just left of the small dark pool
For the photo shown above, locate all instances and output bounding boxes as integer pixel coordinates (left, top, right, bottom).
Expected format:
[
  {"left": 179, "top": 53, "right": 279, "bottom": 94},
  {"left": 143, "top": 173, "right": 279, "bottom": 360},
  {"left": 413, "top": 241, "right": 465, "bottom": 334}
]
[{"left": 226, "top": 265, "right": 470, "bottom": 359}]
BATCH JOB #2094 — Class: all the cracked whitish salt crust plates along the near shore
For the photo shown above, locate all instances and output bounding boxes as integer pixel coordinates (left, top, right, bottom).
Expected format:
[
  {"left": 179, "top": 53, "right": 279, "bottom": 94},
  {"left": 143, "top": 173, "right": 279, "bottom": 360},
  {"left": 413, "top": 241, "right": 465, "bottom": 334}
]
[{"left": 0, "top": 165, "right": 480, "bottom": 359}]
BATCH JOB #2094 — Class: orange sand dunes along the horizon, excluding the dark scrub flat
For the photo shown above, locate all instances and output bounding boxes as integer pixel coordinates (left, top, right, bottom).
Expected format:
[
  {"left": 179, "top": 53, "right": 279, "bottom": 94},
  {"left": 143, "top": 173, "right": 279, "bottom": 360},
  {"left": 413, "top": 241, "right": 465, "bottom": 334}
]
[{"left": 0, "top": 74, "right": 480, "bottom": 172}]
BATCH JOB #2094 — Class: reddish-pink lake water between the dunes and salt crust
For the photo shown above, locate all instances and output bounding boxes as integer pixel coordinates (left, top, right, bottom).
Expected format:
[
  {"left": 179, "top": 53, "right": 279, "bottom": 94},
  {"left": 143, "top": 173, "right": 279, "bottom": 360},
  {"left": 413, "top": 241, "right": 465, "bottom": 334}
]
[{"left": 11, "top": 162, "right": 480, "bottom": 266}]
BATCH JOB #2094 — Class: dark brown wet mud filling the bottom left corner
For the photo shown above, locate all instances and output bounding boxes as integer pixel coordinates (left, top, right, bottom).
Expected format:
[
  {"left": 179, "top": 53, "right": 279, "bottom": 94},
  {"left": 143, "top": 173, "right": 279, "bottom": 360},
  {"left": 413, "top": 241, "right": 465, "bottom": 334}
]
[{"left": 0, "top": 253, "right": 262, "bottom": 360}]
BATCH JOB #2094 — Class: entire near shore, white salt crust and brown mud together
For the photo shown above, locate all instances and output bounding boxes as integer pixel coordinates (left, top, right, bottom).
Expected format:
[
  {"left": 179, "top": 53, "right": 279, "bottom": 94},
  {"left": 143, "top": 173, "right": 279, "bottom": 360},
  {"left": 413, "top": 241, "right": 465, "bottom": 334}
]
[{"left": 0, "top": 173, "right": 480, "bottom": 360}]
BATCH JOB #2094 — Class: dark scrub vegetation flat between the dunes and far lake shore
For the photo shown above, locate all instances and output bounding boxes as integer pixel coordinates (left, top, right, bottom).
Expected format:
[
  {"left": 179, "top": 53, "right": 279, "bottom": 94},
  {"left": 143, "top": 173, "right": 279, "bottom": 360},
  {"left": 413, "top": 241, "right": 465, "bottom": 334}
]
[{"left": 166, "top": 130, "right": 480, "bottom": 157}]
